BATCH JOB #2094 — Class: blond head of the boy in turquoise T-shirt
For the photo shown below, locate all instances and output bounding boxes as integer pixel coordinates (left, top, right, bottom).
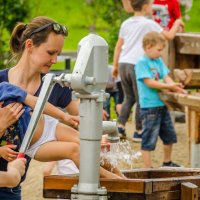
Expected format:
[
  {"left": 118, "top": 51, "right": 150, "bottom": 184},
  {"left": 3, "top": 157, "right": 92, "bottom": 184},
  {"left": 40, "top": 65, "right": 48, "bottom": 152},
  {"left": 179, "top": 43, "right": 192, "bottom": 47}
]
[{"left": 143, "top": 31, "right": 166, "bottom": 59}]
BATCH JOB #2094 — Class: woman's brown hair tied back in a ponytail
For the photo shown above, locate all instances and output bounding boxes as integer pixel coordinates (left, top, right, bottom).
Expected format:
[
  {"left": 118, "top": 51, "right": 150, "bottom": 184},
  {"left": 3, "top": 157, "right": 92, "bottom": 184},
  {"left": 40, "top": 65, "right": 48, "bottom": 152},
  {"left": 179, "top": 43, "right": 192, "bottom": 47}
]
[{"left": 10, "top": 16, "right": 66, "bottom": 58}]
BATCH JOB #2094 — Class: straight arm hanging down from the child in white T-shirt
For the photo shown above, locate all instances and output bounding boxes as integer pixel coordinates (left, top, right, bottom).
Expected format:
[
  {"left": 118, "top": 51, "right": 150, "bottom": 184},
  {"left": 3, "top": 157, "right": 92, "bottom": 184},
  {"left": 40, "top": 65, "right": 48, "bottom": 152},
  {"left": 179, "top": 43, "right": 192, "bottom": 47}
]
[{"left": 113, "top": 38, "right": 124, "bottom": 78}]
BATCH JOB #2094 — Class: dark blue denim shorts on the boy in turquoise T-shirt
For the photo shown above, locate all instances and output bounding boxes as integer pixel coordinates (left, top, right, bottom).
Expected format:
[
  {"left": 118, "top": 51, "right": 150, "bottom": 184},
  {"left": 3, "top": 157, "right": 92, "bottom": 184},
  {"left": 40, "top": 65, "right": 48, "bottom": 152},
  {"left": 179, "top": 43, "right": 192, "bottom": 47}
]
[{"left": 140, "top": 106, "right": 177, "bottom": 151}]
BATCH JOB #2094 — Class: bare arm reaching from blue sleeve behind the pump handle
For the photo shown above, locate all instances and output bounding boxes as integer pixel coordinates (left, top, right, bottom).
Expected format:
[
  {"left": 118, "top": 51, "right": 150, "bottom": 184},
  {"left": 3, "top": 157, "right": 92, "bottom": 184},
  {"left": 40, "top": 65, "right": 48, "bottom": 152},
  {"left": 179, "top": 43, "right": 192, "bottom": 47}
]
[{"left": 23, "top": 94, "right": 79, "bottom": 127}]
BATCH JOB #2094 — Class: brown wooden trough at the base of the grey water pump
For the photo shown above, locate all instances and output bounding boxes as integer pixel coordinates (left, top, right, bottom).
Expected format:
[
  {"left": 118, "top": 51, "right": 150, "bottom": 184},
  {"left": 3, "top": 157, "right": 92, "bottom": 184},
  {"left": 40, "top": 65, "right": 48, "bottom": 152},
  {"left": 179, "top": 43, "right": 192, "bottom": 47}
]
[{"left": 43, "top": 168, "right": 200, "bottom": 200}]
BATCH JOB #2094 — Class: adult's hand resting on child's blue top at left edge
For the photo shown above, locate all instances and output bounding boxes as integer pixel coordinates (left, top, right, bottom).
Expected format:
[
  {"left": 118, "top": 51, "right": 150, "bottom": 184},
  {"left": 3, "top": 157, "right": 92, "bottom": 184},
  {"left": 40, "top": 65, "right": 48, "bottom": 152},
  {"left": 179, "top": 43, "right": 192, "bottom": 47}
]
[{"left": 0, "top": 102, "right": 24, "bottom": 137}]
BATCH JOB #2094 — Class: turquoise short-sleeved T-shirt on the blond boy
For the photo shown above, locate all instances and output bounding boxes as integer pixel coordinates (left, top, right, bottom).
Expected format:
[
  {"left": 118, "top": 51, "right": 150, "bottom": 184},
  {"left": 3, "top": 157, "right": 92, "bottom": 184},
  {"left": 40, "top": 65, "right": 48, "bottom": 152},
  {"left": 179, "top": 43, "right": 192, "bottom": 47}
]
[{"left": 135, "top": 56, "right": 169, "bottom": 108}]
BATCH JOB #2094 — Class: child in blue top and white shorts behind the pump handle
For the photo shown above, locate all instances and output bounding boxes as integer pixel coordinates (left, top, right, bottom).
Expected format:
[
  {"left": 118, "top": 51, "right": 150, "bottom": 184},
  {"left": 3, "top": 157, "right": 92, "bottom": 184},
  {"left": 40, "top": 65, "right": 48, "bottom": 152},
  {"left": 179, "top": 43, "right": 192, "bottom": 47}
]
[{"left": 0, "top": 82, "right": 125, "bottom": 178}]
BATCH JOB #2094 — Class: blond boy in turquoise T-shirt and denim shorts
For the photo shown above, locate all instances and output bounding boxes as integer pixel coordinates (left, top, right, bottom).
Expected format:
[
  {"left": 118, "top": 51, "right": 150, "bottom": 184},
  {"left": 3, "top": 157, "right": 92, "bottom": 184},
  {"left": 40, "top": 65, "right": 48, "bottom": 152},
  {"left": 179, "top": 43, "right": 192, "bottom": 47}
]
[{"left": 135, "top": 32, "right": 186, "bottom": 167}]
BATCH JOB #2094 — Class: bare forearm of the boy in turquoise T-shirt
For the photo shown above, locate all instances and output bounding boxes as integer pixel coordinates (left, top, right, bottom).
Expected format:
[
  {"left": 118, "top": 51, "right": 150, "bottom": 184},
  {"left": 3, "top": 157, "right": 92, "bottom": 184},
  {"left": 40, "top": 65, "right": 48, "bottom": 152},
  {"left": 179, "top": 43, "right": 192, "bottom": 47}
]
[{"left": 144, "top": 76, "right": 187, "bottom": 94}]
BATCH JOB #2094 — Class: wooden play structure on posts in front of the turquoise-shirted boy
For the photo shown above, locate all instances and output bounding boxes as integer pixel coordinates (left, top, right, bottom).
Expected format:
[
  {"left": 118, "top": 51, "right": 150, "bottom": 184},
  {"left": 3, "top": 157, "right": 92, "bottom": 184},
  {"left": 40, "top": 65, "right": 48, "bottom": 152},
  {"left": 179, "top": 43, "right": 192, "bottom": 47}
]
[{"left": 161, "top": 33, "right": 200, "bottom": 167}]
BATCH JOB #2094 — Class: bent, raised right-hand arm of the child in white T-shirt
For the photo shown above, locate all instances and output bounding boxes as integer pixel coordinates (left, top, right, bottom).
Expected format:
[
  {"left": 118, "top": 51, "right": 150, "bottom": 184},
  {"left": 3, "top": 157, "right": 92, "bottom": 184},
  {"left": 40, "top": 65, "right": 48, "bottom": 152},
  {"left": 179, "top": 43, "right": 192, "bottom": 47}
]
[{"left": 161, "top": 19, "right": 184, "bottom": 40}]
